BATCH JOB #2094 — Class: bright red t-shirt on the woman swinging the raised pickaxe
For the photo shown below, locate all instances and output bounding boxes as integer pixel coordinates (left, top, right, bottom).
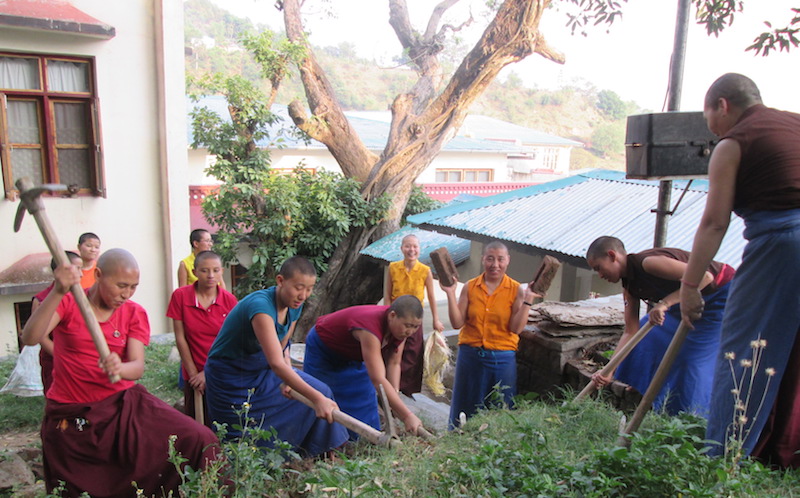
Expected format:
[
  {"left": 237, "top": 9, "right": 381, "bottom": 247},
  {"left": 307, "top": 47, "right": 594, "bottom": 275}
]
[{"left": 47, "top": 294, "right": 150, "bottom": 403}]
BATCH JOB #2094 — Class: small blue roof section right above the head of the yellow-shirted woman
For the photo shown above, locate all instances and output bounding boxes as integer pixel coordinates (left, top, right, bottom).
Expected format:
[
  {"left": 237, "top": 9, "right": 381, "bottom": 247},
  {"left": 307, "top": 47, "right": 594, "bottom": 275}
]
[{"left": 359, "top": 226, "right": 470, "bottom": 265}]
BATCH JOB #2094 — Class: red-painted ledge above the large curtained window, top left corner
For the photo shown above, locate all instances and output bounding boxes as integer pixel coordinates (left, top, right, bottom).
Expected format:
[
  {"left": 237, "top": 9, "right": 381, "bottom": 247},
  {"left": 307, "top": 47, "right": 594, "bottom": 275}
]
[{"left": 0, "top": 0, "right": 117, "bottom": 39}]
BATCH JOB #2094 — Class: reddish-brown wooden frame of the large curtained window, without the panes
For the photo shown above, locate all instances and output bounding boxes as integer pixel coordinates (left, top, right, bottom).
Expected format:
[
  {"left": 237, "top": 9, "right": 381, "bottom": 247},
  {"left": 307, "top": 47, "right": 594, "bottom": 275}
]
[{"left": 0, "top": 51, "right": 107, "bottom": 200}]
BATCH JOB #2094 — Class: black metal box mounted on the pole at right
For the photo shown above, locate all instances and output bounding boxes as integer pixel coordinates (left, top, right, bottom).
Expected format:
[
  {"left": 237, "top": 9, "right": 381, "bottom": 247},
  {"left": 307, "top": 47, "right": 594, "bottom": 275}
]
[{"left": 625, "top": 112, "right": 718, "bottom": 179}]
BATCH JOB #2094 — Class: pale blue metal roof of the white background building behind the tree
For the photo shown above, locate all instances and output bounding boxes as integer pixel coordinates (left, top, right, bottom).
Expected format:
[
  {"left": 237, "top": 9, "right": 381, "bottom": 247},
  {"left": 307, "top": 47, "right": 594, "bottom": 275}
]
[{"left": 186, "top": 95, "right": 525, "bottom": 154}]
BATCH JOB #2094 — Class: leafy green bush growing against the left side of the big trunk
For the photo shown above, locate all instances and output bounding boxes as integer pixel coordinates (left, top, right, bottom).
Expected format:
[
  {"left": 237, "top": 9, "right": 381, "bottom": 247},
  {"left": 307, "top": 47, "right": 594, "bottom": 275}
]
[{"left": 191, "top": 38, "right": 390, "bottom": 296}]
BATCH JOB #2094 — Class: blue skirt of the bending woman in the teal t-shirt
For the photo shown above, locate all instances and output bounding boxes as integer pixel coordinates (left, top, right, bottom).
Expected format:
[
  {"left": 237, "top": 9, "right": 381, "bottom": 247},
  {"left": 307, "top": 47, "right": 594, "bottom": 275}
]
[{"left": 205, "top": 352, "right": 347, "bottom": 456}]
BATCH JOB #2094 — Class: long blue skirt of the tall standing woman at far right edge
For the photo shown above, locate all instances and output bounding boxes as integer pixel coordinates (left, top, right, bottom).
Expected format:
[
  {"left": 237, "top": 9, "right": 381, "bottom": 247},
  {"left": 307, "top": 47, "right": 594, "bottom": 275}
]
[{"left": 706, "top": 209, "right": 800, "bottom": 455}]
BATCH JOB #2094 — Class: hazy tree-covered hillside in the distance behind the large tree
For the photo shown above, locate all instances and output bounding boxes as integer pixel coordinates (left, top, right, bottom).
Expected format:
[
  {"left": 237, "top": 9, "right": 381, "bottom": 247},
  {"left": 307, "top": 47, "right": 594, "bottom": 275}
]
[{"left": 184, "top": 0, "right": 642, "bottom": 169}]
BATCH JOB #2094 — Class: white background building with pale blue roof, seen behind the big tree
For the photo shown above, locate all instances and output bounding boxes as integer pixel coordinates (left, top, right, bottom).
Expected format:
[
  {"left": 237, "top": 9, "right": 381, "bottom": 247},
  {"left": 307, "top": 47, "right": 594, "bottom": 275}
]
[{"left": 188, "top": 97, "right": 582, "bottom": 219}]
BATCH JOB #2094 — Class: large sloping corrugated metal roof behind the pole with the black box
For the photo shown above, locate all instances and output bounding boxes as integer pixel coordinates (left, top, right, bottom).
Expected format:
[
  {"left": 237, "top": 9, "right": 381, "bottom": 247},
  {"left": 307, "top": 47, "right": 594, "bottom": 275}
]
[{"left": 408, "top": 170, "right": 745, "bottom": 266}]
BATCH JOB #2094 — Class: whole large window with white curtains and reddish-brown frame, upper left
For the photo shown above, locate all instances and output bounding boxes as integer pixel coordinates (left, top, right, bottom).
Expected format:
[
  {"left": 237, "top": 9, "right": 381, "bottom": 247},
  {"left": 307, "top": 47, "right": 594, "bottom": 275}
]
[{"left": 0, "top": 53, "right": 105, "bottom": 199}]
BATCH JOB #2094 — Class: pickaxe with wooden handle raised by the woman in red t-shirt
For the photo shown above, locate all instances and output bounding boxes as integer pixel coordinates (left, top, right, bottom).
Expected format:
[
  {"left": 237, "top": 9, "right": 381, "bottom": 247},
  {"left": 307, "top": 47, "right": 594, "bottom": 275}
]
[{"left": 14, "top": 178, "right": 120, "bottom": 383}]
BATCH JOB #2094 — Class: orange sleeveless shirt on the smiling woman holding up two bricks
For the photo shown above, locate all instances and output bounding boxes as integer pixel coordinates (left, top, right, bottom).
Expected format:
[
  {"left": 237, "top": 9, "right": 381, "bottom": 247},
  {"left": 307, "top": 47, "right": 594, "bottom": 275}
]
[{"left": 458, "top": 274, "right": 519, "bottom": 351}]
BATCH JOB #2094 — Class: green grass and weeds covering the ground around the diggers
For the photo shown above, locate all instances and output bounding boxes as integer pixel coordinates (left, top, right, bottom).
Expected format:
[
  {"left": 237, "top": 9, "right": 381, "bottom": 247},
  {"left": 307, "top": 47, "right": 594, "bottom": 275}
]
[{"left": 0, "top": 344, "right": 800, "bottom": 497}]
